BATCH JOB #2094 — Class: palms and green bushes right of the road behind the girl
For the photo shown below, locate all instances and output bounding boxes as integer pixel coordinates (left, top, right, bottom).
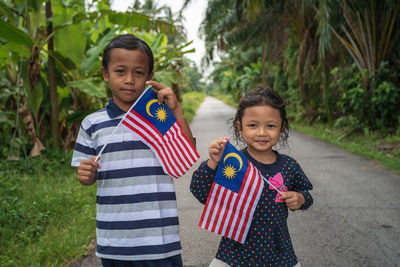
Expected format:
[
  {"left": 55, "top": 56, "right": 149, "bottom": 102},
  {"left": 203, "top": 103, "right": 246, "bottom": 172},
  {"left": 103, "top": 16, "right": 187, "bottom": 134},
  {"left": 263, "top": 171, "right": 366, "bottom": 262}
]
[{"left": 202, "top": 0, "right": 400, "bottom": 136}]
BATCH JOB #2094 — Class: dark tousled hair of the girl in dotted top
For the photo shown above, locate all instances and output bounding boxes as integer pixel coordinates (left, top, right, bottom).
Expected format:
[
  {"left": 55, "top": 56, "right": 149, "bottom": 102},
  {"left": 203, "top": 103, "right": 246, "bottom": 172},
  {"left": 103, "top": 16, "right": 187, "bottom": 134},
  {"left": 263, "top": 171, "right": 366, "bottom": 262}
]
[{"left": 232, "top": 85, "right": 289, "bottom": 150}]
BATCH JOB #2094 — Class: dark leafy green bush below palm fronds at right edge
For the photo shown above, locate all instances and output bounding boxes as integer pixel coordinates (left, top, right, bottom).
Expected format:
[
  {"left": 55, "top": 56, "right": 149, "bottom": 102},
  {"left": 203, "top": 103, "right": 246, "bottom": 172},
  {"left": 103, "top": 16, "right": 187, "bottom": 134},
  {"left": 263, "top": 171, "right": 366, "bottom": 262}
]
[{"left": 331, "top": 65, "right": 400, "bottom": 131}]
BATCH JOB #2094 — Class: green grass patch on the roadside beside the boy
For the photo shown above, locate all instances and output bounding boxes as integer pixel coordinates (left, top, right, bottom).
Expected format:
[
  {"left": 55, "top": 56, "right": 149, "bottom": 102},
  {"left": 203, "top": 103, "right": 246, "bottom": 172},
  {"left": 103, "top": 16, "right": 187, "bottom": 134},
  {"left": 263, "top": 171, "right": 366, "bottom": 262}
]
[{"left": 0, "top": 153, "right": 96, "bottom": 267}]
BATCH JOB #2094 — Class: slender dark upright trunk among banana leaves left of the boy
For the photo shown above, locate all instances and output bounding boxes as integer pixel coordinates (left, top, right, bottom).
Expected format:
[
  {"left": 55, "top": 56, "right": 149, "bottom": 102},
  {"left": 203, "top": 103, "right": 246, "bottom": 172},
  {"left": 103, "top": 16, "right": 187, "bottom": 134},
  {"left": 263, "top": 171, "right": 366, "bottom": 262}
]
[{"left": 46, "top": 0, "right": 60, "bottom": 147}]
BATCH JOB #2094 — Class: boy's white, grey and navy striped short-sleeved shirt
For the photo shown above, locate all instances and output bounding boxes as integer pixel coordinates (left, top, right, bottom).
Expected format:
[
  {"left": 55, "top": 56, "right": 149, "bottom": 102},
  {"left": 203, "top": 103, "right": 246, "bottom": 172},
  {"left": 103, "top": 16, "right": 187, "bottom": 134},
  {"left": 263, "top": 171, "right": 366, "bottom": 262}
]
[{"left": 72, "top": 100, "right": 181, "bottom": 260}]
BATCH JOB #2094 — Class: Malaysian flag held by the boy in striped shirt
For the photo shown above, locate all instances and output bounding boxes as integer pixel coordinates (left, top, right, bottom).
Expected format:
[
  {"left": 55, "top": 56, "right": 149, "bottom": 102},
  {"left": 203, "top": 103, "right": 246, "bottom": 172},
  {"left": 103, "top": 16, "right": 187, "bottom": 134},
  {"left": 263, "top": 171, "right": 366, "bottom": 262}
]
[{"left": 122, "top": 87, "right": 200, "bottom": 178}]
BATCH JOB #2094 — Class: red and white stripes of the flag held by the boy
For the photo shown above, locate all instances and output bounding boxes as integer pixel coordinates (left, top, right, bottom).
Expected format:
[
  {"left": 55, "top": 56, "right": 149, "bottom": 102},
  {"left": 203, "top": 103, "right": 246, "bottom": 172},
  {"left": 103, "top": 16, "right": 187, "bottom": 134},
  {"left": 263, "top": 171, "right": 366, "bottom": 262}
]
[{"left": 122, "top": 108, "right": 200, "bottom": 178}]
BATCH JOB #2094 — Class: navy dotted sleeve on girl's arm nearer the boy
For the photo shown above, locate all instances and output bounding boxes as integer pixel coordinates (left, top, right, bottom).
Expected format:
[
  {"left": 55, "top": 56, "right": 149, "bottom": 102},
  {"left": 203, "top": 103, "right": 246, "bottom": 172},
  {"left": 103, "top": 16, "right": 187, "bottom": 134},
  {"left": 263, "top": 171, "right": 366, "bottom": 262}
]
[{"left": 190, "top": 160, "right": 216, "bottom": 204}]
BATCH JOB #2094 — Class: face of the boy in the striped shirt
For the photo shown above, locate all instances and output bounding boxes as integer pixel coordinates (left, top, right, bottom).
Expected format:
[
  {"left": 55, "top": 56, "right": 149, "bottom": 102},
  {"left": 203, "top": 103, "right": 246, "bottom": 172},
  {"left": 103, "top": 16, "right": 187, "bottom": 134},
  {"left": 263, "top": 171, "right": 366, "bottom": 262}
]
[{"left": 101, "top": 48, "right": 154, "bottom": 111}]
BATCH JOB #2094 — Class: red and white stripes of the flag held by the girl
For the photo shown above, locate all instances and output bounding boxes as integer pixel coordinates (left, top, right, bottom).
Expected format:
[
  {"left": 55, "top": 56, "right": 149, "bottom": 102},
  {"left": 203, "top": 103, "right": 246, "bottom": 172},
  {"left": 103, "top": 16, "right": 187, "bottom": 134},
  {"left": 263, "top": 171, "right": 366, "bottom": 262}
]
[{"left": 199, "top": 160, "right": 264, "bottom": 244}]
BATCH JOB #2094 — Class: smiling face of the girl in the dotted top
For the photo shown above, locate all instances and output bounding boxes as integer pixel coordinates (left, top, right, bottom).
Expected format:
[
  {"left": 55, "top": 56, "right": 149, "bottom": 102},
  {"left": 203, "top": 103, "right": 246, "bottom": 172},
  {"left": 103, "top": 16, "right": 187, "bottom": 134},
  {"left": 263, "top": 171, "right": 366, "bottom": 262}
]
[{"left": 237, "top": 105, "right": 282, "bottom": 159}]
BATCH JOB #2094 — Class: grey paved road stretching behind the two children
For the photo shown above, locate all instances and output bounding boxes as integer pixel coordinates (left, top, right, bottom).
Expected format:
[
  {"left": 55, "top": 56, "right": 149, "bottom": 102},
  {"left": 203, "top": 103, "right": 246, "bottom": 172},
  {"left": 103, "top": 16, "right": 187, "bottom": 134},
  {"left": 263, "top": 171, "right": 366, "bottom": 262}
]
[{"left": 74, "top": 97, "right": 400, "bottom": 267}]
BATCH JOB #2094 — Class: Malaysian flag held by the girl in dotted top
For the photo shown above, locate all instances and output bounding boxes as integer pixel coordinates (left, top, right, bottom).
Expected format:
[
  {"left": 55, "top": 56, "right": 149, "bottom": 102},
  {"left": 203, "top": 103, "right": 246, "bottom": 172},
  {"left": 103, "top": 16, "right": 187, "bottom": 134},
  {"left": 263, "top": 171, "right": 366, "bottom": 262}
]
[{"left": 199, "top": 142, "right": 264, "bottom": 244}]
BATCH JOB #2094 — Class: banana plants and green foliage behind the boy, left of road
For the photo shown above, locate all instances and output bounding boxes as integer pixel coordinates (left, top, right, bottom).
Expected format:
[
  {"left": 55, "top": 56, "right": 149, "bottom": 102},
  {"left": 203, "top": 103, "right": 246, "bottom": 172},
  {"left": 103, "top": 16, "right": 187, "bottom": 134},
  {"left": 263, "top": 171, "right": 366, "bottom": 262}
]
[{"left": 0, "top": 0, "right": 204, "bottom": 158}]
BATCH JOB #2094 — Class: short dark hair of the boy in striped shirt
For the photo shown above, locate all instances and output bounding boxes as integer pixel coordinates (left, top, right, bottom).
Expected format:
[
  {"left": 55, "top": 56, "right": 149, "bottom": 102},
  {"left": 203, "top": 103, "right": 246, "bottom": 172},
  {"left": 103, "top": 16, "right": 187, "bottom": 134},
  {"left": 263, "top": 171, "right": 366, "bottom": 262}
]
[{"left": 102, "top": 34, "right": 154, "bottom": 74}]
